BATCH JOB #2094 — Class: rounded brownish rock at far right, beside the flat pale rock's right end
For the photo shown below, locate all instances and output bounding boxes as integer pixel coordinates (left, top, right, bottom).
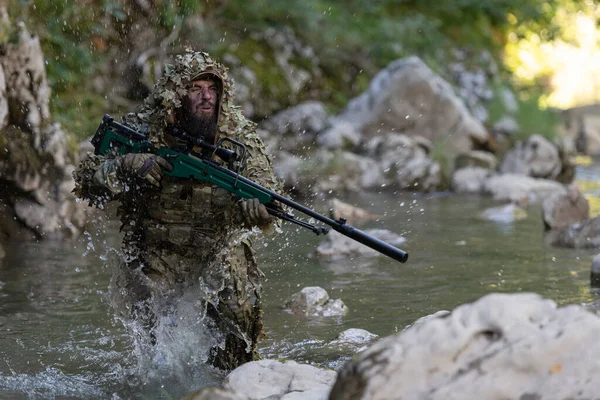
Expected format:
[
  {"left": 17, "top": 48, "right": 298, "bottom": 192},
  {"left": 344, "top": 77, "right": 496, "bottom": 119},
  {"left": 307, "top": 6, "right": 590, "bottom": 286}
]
[{"left": 542, "top": 184, "right": 590, "bottom": 230}]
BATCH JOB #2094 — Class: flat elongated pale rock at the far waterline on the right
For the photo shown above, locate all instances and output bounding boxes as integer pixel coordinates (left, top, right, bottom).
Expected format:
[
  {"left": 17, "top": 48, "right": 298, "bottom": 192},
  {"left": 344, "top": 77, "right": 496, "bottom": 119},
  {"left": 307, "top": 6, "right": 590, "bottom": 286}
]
[{"left": 483, "top": 174, "right": 566, "bottom": 203}]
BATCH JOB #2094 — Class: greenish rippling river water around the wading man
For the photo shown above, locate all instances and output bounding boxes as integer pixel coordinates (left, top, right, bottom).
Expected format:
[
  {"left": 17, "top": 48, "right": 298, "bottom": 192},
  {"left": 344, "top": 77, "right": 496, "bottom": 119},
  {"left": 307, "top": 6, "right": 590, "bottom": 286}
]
[{"left": 0, "top": 166, "right": 600, "bottom": 399}]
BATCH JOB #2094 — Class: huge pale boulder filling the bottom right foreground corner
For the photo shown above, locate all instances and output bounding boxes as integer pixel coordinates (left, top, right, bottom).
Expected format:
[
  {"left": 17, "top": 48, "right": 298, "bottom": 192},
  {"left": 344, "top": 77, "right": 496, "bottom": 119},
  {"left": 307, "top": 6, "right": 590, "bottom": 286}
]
[{"left": 329, "top": 293, "right": 600, "bottom": 400}]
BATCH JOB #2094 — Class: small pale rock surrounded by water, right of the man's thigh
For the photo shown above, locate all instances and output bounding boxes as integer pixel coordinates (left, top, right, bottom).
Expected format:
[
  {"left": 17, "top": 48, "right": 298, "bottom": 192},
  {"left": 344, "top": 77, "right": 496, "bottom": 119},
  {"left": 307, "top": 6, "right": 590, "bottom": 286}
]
[{"left": 284, "top": 286, "right": 348, "bottom": 317}]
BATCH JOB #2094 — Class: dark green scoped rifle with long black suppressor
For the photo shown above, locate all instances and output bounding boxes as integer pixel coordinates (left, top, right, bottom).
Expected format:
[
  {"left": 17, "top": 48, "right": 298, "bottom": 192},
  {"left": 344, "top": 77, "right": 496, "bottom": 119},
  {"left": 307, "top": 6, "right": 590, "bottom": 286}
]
[{"left": 92, "top": 115, "right": 408, "bottom": 263}]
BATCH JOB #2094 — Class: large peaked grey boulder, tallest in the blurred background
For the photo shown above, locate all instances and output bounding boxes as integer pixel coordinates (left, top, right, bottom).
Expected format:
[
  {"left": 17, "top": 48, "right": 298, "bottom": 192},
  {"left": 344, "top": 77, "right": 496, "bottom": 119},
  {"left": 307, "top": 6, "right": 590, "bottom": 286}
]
[{"left": 338, "top": 56, "right": 491, "bottom": 154}]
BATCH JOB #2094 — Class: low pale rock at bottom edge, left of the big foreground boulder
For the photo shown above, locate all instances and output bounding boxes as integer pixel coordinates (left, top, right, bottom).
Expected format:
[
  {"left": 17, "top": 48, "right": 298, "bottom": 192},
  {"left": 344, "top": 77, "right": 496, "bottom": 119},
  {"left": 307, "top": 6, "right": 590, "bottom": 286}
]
[{"left": 185, "top": 360, "right": 337, "bottom": 400}]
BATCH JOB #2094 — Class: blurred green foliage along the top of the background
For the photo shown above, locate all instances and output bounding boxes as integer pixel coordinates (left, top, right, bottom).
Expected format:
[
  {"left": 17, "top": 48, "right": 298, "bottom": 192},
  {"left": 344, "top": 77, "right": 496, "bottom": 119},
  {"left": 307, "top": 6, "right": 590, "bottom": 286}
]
[{"left": 8, "top": 0, "right": 582, "bottom": 139}]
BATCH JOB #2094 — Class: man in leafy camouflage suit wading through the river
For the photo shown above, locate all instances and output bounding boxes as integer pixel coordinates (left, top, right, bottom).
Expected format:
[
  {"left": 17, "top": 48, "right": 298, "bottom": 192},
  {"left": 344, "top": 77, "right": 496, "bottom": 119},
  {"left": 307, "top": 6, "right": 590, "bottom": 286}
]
[{"left": 74, "top": 50, "right": 280, "bottom": 370}]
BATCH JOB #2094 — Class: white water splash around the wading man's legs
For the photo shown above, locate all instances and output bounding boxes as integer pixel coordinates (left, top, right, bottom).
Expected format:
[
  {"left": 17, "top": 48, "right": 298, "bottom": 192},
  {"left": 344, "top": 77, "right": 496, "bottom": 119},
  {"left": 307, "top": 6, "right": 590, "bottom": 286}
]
[{"left": 107, "top": 255, "right": 224, "bottom": 396}]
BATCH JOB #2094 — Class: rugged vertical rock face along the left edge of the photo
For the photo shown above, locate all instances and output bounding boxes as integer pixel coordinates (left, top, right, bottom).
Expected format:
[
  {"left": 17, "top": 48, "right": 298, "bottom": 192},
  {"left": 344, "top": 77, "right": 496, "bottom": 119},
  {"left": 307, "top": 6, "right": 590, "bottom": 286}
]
[{"left": 0, "top": 17, "right": 87, "bottom": 242}]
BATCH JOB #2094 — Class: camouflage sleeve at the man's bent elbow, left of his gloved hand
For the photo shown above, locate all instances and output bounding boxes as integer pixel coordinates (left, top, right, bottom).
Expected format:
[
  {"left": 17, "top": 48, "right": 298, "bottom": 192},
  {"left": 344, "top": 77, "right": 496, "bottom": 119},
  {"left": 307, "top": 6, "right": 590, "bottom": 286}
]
[{"left": 73, "top": 153, "right": 126, "bottom": 208}]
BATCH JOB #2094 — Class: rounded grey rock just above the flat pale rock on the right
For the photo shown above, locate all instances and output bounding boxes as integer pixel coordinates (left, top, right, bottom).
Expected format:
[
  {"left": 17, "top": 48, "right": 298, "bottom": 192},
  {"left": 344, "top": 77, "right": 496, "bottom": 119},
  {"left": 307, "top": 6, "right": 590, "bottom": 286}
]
[{"left": 500, "top": 135, "right": 562, "bottom": 179}]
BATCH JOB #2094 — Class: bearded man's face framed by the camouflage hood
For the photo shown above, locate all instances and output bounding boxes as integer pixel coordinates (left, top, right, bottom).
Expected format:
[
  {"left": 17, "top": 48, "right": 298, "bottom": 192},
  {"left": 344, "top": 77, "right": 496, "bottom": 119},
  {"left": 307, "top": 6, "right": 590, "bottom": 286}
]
[{"left": 180, "top": 78, "right": 219, "bottom": 143}]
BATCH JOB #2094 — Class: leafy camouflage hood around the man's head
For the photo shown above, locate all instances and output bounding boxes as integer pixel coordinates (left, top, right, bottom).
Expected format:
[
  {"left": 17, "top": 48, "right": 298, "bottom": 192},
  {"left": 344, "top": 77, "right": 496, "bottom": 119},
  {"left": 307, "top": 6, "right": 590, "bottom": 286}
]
[{"left": 125, "top": 49, "right": 251, "bottom": 143}]
